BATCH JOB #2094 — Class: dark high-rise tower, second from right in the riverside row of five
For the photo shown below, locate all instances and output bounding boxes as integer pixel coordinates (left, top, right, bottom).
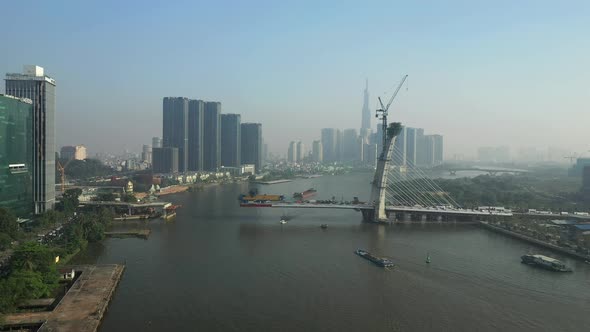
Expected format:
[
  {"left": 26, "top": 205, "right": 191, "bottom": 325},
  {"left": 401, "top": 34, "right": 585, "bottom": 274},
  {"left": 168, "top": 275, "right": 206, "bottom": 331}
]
[{"left": 221, "top": 114, "right": 242, "bottom": 167}]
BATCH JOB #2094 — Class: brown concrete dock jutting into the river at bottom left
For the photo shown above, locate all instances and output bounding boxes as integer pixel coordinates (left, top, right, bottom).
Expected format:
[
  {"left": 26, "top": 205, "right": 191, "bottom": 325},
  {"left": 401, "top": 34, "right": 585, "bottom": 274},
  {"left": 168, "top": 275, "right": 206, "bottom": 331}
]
[{"left": 3, "top": 264, "right": 125, "bottom": 332}]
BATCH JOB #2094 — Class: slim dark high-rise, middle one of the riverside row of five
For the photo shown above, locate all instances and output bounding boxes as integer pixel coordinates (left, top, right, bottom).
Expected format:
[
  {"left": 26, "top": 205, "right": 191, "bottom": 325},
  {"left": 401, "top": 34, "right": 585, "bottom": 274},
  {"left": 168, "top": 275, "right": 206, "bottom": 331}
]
[{"left": 203, "top": 101, "right": 221, "bottom": 172}]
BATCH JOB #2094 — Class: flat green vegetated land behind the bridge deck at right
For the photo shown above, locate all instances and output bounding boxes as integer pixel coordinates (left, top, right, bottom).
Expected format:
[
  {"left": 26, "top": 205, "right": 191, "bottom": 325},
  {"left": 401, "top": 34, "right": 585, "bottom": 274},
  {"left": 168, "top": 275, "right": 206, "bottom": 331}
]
[{"left": 435, "top": 175, "right": 589, "bottom": 211}]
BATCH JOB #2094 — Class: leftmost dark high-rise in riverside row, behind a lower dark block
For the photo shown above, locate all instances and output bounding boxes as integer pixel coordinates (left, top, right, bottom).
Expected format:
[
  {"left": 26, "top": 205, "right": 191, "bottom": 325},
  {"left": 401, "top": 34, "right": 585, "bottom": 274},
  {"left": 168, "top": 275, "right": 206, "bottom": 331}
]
[{"left": 162, "top": 97, "right": 188, "bottom": 172}]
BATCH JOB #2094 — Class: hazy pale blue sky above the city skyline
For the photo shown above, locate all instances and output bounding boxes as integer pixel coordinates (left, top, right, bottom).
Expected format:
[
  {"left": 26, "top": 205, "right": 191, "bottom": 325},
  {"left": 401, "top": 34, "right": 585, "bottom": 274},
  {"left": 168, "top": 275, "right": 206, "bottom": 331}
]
[{"left": 0, "top": 0, "right": 590, "bottom": 157}]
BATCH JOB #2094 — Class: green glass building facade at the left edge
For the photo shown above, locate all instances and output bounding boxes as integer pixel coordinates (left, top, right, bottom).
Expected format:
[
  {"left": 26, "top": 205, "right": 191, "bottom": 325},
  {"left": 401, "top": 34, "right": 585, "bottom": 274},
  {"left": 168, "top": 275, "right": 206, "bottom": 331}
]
[{"left": 0, "top": 95, "right": 34, "bottom": 217}]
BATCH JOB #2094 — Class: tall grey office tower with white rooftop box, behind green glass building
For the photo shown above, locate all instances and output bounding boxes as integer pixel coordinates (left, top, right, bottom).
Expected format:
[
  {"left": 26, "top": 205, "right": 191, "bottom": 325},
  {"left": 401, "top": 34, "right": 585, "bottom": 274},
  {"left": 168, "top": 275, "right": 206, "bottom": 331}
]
[{"left": 5, "top": 65, "right": 55, "bottom": 214}]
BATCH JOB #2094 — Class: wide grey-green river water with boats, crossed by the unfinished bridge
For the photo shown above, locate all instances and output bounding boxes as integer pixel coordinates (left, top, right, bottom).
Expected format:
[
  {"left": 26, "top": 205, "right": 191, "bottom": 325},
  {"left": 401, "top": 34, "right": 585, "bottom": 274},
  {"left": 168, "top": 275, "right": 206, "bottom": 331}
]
[{"left": 77, "top": 173, "right": 590, "bottom": 331}]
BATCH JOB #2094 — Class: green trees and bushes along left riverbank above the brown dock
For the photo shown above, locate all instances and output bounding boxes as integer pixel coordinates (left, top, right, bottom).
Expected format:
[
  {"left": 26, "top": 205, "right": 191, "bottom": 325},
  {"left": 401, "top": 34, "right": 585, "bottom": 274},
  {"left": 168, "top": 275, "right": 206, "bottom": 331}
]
[{"left": 0, "top": 189, "right": 114, "bottom": 319}]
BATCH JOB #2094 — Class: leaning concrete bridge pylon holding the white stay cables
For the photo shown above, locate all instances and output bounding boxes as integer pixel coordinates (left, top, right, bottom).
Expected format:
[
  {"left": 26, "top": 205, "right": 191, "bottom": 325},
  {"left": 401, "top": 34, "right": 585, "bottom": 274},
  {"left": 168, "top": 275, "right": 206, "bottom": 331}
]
[{"left": 363, "top": 122, "right": 402, "bottom": 222}]
